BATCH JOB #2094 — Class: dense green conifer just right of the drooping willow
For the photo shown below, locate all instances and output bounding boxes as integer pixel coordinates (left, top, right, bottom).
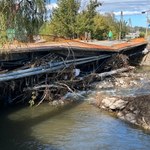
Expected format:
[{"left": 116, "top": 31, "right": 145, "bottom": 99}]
[{"left": 51, "top": 0, "right": 80, "bottom": 38}]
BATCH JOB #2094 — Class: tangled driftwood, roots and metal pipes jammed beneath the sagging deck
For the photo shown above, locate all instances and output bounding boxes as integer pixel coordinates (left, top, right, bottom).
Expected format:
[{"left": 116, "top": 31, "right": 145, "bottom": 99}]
[{"left": 0, "top": 54, "right": 133, "bottom": 105}]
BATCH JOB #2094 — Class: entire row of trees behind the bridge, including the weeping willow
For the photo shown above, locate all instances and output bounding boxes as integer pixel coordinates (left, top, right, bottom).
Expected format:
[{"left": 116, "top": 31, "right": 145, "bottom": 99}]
[{"left": 0, "top": 0, "right": 128, "bottom": 44}]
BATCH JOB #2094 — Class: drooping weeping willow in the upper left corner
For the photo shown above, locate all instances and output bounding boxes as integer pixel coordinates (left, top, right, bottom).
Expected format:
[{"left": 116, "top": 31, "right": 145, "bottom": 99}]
[{"left": 0, "top": 0, "right": 46, "bottom": 40}]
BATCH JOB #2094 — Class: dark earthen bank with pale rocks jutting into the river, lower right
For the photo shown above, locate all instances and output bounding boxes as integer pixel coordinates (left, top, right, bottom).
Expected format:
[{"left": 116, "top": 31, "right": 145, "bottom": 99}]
[{"left": 96, "top": 95, "right": 150, "bottom": 129}]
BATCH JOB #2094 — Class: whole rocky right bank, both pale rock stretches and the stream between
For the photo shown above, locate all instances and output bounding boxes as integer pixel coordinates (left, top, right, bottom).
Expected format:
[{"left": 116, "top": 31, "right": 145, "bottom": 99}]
[{"left": 90, "top": 68, "right": 150, "bottom": 130}]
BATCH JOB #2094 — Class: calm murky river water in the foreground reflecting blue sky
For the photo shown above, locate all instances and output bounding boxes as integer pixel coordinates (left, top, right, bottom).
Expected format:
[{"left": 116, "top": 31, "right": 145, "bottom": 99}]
[{"left": 0, "top": 66, "right": 150, "bottom": 150}]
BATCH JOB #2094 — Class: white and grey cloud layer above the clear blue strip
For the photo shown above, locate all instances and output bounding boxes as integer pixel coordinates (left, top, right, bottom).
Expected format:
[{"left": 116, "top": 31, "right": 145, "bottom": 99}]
[{"left": 46, "top": 0, "right": 150, "bottom": 15}]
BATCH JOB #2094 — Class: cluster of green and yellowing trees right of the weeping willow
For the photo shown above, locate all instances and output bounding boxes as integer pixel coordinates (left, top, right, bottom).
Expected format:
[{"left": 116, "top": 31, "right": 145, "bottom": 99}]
[{"left": 40, "top": 0, "right": 127, "bottom": 40}]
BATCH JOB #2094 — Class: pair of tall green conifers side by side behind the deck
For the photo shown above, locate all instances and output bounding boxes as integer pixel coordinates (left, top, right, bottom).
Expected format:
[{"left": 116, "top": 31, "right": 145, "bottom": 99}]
[{"left": 50, "top": 0, "right": 100, "bottom": 38}]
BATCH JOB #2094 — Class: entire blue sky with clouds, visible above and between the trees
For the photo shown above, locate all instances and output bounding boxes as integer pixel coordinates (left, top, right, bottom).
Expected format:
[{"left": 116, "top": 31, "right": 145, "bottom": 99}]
[{"left": 46, "top": 0, "right": 150, "bottom": 27}]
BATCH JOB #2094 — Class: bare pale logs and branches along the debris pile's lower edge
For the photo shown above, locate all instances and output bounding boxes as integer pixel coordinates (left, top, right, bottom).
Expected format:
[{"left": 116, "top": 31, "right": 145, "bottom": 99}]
[{"left": 25, "top": 66, "right": 134, "bottom": 105}]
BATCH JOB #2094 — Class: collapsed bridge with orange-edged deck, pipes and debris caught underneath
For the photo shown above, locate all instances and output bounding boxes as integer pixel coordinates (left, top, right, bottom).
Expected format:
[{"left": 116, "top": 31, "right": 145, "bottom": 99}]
[{"left": 0, "top": 38, "right": 147, "bottom": 103}]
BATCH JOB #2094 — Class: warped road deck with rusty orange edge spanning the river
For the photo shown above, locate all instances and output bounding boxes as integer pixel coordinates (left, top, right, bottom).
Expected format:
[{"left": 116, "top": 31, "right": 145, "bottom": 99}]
[{"left": 0, "top": 38, "right": 147, "bottom": 53}]
